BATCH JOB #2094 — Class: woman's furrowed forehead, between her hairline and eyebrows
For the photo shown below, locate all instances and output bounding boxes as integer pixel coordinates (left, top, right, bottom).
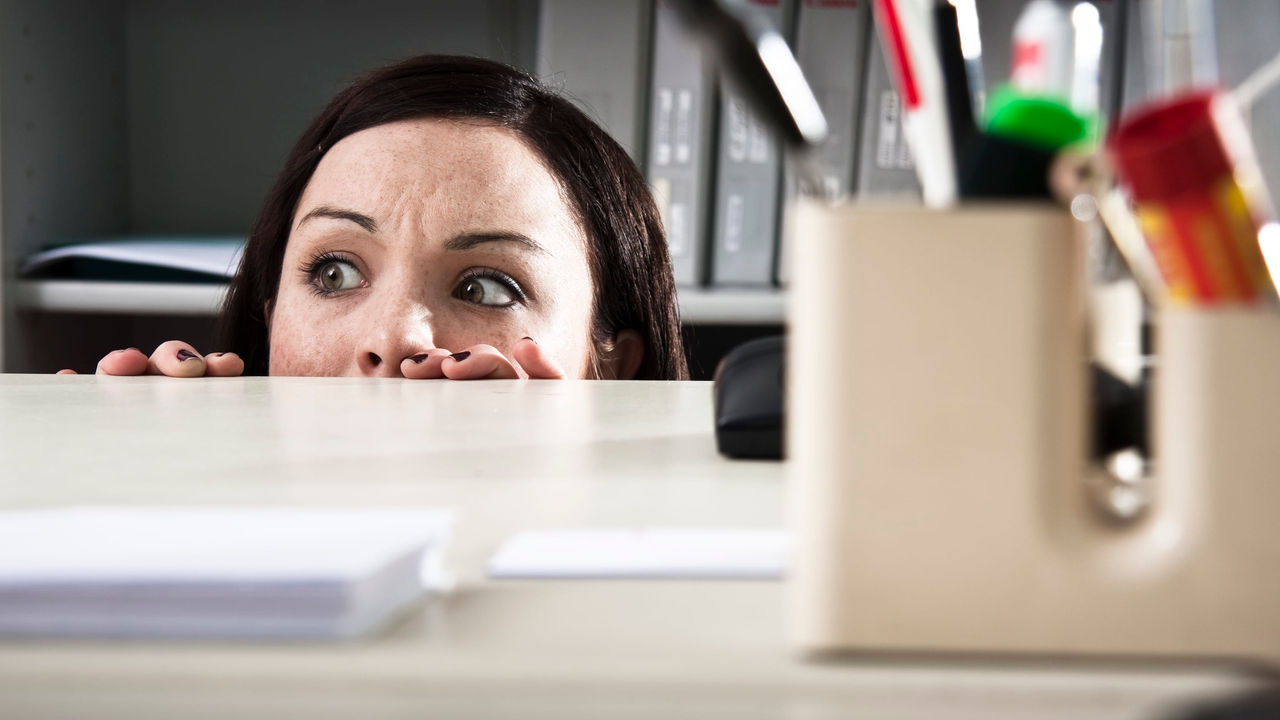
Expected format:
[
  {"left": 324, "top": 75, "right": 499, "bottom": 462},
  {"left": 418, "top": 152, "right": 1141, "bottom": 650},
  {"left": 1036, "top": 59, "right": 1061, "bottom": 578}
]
[{"left": 294, "top": 119, "right": 580, "bottom": 234}]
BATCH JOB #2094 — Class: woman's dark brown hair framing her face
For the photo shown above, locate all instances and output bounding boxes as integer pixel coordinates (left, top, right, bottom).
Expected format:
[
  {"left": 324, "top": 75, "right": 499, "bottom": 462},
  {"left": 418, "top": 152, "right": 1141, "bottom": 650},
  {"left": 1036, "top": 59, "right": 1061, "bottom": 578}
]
[{"left": 220, "top": 55, "right": 689, "bottom": 379}]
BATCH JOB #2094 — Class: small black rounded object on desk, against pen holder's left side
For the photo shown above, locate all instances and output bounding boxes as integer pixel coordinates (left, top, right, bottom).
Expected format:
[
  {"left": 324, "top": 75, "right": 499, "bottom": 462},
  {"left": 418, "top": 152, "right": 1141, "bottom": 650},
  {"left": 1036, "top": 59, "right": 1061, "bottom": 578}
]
[{"left": 713, "top": 336, "right": 786, "bottom": 460}]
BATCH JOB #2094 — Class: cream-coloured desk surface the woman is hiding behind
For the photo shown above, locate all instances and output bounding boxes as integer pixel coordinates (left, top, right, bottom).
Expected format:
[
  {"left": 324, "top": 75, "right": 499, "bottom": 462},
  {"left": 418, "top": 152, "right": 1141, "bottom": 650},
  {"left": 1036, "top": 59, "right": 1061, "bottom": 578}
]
[{"left": 0, "top": 375, "right": 1258, "bottom": 720}]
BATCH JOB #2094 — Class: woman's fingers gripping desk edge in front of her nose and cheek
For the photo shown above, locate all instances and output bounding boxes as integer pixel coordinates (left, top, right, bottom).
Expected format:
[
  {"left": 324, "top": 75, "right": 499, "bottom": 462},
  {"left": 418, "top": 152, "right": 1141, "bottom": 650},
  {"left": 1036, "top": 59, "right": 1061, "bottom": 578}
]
[{"left": 401, "top": 337, "right": 564, "bottom": 380}]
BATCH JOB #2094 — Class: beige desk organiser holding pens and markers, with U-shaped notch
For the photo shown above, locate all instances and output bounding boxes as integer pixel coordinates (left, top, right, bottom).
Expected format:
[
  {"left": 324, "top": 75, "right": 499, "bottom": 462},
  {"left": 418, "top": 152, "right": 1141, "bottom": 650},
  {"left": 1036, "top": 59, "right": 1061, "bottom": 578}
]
[{"left": 787, "top": 201, "right": 1280, "bottom": 661}]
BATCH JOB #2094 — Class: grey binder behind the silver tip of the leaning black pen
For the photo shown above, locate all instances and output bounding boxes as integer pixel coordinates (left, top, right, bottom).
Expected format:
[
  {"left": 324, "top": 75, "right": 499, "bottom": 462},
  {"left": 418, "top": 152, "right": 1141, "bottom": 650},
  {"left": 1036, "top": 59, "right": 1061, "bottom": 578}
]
[{"left": 777, "top": 0, "right": 870, "bottom": 284}]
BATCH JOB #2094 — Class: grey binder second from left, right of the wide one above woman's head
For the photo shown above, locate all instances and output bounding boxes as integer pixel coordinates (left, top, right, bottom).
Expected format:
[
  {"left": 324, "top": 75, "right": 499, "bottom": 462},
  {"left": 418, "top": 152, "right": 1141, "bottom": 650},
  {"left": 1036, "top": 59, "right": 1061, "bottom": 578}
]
[{"left": 646, "top": 0, "right": 716, "bottom": 287}]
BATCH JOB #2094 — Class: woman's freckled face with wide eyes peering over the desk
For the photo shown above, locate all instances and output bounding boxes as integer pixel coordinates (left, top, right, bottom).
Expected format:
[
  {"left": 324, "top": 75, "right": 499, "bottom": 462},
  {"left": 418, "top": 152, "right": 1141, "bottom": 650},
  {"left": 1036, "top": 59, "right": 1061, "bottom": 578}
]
[{"left": 268, "top": 119, "right": 593, "bottom": 377}]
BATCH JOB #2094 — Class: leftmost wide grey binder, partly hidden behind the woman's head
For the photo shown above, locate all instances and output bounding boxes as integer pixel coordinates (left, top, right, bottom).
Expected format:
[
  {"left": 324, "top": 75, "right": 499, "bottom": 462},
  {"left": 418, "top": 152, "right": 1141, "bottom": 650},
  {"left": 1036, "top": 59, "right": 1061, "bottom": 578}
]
[{"left": 538, "top": 0, "right": 649, "bottom": 161}]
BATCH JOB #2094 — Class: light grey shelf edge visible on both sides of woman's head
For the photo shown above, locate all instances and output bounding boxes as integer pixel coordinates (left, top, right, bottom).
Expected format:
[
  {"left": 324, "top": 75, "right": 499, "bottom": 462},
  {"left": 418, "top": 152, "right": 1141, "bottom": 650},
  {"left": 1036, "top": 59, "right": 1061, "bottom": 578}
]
[{"left": 14, "top": 281, "right": 786, "bottom": 325}]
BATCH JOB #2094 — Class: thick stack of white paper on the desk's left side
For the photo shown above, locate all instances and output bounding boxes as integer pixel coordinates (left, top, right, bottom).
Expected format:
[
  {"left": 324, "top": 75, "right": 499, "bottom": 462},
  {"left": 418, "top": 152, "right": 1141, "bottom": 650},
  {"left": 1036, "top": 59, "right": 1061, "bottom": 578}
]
[{"left": 0, "top": 507, "right": 452, "bottom": 638}]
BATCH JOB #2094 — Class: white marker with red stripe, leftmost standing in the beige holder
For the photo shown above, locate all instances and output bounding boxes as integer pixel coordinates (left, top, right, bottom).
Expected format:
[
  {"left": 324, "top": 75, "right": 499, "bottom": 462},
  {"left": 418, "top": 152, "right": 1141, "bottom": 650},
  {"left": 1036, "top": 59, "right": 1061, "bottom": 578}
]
[{"left": 872, "top": 0, "right": 957, "bottom": 209}]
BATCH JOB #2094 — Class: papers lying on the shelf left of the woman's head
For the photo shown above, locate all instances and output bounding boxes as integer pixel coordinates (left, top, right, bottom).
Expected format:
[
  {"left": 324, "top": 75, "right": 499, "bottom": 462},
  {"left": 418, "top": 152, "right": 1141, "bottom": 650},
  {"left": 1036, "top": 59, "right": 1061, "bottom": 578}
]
[{"left": 18, "top": 238, "right": 244, "bottom": 278}]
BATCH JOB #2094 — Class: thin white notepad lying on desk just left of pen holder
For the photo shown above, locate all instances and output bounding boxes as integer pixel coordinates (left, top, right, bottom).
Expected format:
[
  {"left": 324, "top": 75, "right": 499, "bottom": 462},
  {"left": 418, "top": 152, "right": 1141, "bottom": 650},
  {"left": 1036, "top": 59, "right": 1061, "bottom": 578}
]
[{"left": 489, "top": 528, "right": 791, "bottom": 580}]
